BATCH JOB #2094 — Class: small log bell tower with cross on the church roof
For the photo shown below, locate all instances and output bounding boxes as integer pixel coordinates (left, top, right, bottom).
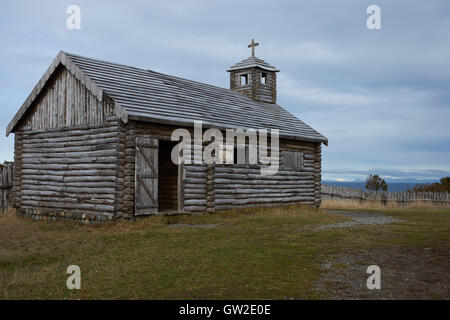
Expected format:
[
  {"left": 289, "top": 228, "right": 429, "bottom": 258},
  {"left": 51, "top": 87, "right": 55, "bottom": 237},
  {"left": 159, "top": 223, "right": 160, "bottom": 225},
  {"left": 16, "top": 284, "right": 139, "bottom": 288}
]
[{"left": 227, "top": 39, "right": 280, "bottom": 103}]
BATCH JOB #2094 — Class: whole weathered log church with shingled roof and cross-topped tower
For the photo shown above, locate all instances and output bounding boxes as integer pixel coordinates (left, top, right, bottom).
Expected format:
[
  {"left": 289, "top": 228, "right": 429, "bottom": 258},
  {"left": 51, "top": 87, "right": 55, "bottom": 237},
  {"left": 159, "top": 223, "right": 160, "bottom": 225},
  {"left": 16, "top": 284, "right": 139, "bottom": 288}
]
[{"left": 6, "top": 41, "right": 327, "bottom": 222}]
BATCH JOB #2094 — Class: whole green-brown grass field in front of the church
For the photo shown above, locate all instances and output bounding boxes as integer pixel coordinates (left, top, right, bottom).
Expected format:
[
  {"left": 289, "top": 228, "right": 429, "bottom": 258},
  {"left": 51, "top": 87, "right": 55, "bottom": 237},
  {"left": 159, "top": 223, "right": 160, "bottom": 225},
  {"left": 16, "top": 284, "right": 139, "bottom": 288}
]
[{"left": 0, "top": 206, "right": 450, "bottom": 299}]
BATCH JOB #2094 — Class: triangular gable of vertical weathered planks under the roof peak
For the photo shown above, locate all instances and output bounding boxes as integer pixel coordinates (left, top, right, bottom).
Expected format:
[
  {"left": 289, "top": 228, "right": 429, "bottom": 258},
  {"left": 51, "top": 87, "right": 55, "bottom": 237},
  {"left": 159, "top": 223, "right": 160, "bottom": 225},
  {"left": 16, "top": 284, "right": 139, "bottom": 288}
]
[{"left": 6, "top": 51, "right": 128, "bottom": 136}]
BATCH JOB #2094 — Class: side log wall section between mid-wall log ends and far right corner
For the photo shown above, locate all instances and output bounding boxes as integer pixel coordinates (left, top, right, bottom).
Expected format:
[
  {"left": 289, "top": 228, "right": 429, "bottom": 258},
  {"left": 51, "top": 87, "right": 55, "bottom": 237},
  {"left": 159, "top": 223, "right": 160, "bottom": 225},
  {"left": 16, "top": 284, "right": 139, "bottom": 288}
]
[{"left": 213, "top": 141, "right": 320, "bottom": 210}]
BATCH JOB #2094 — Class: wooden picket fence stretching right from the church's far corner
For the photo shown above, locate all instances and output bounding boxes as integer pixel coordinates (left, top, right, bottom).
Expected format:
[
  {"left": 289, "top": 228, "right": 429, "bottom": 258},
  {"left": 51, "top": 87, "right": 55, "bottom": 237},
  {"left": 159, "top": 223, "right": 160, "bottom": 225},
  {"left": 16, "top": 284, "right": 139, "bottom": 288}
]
[{"left": 322, "top": 185, "right": 450, "bottom": 205}]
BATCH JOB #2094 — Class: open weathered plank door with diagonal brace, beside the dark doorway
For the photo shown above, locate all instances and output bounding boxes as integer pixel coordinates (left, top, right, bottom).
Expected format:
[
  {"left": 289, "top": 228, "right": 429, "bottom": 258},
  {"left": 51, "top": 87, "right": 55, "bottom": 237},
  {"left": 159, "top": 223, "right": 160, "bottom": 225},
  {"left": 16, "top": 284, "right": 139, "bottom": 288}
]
[{"left": 135, "top": 137, "right": 158, "bottom": 215}]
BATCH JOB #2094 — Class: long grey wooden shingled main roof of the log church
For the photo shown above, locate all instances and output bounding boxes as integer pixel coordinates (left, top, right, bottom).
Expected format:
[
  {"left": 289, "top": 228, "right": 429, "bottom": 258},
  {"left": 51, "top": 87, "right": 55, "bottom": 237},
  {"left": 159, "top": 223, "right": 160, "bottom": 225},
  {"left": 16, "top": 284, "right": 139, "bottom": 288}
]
[{"left": 6, "top": 51, "right": 328, "bottom": 144}]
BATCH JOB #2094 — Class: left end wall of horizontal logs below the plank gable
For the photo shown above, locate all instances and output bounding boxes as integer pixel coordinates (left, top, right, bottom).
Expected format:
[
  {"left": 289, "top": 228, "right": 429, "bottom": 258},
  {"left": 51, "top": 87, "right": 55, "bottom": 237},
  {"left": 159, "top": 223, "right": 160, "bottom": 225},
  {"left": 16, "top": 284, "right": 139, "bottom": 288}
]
[{"left": 15, "top": 117, "right": 121, "bottom": 220}]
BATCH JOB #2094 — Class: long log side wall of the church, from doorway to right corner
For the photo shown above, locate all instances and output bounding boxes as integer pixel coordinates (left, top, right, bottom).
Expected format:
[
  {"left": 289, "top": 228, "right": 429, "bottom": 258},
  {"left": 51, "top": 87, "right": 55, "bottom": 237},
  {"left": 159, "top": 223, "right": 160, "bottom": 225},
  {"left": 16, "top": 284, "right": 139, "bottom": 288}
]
[{"left": 136, "top": 122, "right": 321, "bottom": 213}]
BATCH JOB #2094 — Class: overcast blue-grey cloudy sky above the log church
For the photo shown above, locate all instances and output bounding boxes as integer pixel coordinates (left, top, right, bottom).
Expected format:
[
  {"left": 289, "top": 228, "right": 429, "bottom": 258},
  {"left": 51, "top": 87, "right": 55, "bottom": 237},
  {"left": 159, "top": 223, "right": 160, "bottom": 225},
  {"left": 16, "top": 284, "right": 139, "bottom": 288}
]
[{"left": 0, "top": 0, "right": 450, "bottom": 180}]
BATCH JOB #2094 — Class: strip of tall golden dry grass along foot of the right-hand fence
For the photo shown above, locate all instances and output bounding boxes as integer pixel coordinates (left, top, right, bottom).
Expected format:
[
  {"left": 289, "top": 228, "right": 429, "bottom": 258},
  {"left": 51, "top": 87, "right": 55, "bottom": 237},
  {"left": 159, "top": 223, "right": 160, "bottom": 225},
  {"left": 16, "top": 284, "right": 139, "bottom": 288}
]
[{"left": 320, "top": 199, "right": 450, "bottom": 210}]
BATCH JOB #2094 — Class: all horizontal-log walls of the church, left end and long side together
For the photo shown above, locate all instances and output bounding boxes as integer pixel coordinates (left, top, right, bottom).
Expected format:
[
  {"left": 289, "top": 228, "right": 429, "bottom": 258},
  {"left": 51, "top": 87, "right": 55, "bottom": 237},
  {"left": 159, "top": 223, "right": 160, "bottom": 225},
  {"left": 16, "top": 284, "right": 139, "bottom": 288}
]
[{"left": 14, "top": 116, "right": 320, "bottom": 220}]
